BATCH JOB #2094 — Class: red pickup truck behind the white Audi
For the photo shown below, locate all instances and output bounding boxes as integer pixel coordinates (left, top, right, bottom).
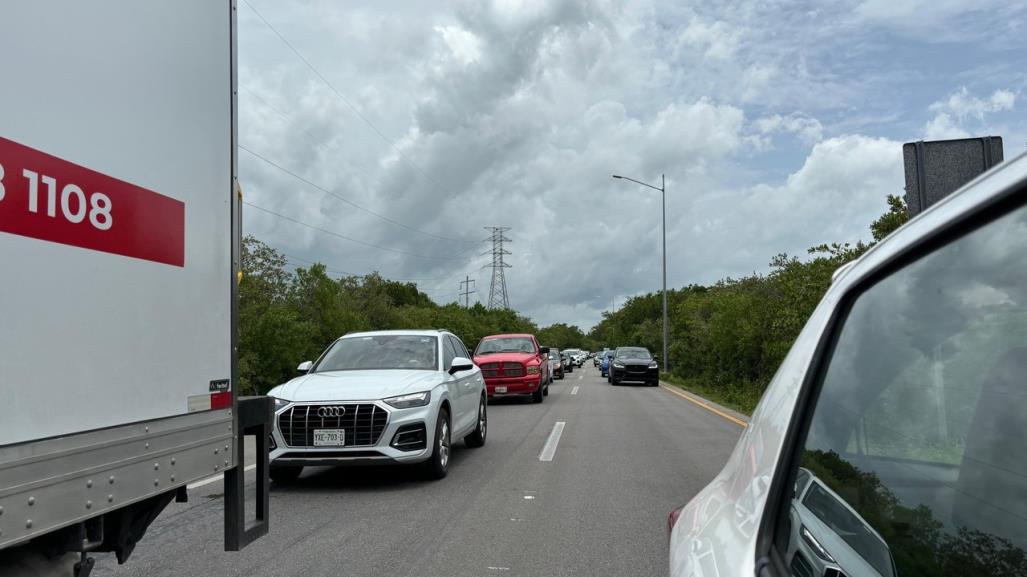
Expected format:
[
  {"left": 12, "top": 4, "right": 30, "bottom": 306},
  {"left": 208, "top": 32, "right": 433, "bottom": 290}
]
[{"left": 474, "top": 335, "right": 553, "bottom": 402}]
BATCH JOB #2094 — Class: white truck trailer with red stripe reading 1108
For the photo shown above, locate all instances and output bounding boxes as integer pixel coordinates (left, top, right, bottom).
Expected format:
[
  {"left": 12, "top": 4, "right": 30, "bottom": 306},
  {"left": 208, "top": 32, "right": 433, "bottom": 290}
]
[{"left": 0, "top": 0, "right": 271, "bottom": 575}]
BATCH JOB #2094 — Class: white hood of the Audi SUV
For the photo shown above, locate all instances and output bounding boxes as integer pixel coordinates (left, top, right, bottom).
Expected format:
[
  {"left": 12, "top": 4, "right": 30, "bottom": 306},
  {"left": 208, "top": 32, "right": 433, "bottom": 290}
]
[{"left": 268, "top": 370, "right": 445, "bottom": 402}]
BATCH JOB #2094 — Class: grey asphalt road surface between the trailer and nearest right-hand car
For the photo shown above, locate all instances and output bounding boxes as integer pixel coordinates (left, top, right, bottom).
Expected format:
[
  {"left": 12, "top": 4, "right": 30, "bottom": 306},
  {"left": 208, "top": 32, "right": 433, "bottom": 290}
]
[{"left": 93, "top": 361, "right": 741, "bottom": 577}]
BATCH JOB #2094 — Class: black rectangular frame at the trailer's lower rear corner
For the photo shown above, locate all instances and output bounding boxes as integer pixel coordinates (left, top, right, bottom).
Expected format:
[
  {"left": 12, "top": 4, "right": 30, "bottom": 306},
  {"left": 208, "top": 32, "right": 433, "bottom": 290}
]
[{"left": 225, "top": 396, "right": 274, "bottom": 551}]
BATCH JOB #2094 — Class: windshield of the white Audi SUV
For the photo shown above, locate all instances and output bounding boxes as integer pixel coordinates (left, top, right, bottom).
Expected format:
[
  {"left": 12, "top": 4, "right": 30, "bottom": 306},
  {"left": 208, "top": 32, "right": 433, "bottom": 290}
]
[{"left": 311, "top": 335, "right": 439, "bottom": 373}]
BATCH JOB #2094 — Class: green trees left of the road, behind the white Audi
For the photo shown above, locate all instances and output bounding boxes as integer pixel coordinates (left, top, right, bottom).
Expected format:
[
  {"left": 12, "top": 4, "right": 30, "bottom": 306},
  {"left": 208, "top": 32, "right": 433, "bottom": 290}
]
[{"left": 239, "top": 236, "right": 534, "bottom": 394}]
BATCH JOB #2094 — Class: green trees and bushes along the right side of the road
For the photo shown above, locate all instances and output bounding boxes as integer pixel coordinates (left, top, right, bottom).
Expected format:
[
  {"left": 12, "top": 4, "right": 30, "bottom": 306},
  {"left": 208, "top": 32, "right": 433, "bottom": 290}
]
[{"left": 588, "top": 196, "right": 907, "bottom": 414}]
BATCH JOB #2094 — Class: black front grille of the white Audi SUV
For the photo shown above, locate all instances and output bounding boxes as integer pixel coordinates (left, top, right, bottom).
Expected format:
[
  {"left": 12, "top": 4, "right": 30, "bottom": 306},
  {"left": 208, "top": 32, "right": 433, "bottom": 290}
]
[{"left": 278, "top": 402, "right": 388, "bottom": 447}]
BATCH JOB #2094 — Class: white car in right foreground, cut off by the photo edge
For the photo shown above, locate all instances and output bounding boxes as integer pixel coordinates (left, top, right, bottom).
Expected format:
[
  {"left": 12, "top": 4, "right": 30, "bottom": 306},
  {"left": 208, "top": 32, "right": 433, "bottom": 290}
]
[{"left": 668, "top": 155, "right": 1027, "bottom": 577}]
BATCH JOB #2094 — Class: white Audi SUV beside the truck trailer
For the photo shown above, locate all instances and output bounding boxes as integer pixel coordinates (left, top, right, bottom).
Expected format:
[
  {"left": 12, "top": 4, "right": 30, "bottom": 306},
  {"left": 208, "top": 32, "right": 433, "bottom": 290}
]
[{"left": 268, "top": 331, "right": 488, "bottom": 483}]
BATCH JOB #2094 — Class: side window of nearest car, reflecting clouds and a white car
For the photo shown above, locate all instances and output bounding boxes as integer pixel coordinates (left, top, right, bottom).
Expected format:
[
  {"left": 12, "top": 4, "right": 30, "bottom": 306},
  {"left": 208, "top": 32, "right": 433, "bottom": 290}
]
[{"left": 775, "top": 199, "right": 1027, "bottom": 577}]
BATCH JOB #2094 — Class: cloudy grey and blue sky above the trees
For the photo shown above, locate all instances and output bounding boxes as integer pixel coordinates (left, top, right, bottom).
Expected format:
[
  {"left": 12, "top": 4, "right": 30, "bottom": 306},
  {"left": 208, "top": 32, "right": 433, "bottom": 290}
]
[{"left": 238, "top": 0, "right": 1027, "bottom": 329}]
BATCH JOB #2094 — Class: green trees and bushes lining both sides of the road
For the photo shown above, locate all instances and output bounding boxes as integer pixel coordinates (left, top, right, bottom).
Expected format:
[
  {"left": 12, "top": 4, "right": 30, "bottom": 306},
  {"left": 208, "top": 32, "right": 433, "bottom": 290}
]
[{"left": 239, "top": 196, "right": 907, "bottom": 414}]
